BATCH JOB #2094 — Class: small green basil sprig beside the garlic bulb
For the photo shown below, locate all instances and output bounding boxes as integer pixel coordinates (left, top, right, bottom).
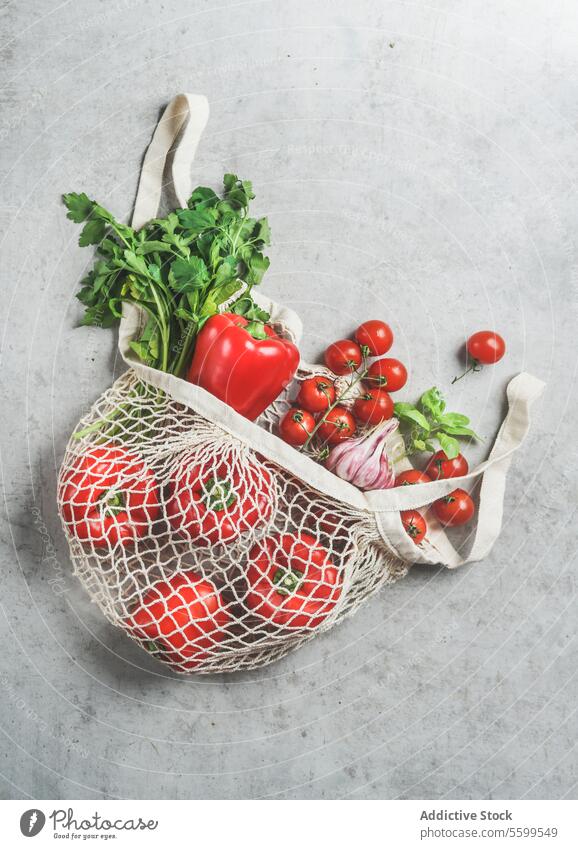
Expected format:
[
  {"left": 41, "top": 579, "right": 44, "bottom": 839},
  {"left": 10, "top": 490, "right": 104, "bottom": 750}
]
[{"left": 393, "top": 386, "right": 479, "bottom": 460}]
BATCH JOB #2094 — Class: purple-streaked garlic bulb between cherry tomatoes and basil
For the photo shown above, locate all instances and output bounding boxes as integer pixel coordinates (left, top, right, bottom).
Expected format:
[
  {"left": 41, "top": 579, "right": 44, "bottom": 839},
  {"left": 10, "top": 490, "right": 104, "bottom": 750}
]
[{"left": 325, "top": 419, "right": 399, "bottom": 492}]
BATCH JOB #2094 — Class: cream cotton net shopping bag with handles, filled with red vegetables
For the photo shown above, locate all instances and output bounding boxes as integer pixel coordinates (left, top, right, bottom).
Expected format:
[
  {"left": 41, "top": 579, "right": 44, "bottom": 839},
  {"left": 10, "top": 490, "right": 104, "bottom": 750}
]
[{"left": 58, "top": 95, "right": 543, "bottom": 673}]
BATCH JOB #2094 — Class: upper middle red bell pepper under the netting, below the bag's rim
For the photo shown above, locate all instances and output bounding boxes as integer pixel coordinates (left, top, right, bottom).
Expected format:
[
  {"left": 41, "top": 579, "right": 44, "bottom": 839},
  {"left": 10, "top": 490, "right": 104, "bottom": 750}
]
[{"left": 167, "top": 460, "right": 273, "bottom": 546}]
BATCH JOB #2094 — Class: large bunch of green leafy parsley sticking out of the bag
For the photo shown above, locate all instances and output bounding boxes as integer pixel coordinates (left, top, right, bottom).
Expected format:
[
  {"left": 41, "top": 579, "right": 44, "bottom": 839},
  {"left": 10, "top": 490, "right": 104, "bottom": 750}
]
[{"left": 63, "top": 174, "right": 270, "bottom": 375}]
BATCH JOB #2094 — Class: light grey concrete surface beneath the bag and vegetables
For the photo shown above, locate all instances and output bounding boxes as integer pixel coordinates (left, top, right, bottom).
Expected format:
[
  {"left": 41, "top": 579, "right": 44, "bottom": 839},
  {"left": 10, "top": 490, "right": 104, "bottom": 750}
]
[{"left": 0, "top": 0, "right": 578, "bottom": 799}]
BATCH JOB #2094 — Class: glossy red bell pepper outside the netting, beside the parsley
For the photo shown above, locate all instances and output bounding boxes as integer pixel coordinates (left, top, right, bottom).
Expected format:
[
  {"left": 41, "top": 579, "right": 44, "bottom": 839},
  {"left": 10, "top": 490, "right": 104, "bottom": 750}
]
[{"left": 187, "top": 313, "right": 299, "bottom": 421}]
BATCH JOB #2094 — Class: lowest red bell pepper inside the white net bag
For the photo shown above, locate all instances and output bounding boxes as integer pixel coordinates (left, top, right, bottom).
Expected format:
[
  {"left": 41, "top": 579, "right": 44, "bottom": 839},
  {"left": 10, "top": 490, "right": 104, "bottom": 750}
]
[{"left": 125, "top": 571, "right": 231, "bottom": 668}]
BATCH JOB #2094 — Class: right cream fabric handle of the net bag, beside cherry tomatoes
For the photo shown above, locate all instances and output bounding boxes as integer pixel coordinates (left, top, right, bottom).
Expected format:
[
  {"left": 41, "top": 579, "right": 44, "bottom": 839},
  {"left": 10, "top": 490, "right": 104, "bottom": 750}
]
[{"left": 366, "top": 372, "right": 545, "bottom": 567}]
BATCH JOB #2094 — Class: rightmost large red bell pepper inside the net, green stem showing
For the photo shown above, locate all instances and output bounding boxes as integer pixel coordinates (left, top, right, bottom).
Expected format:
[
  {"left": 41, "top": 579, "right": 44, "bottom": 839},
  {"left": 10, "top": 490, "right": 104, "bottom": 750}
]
[{"left": 246, "top": 533, "right": 341, "bottom": 629}]
